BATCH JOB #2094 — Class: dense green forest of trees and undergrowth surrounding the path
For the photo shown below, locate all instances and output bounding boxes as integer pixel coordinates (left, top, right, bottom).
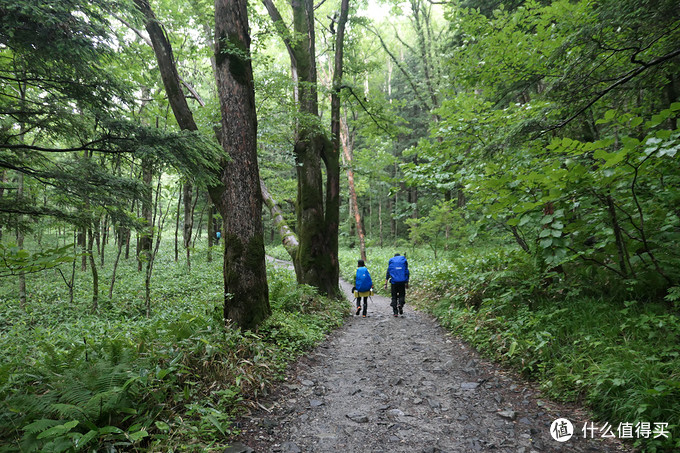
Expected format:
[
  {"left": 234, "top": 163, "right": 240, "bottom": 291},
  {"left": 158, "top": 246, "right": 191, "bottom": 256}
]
[{"left": 0, "top": 0, "right": 680, "bottom": 452}]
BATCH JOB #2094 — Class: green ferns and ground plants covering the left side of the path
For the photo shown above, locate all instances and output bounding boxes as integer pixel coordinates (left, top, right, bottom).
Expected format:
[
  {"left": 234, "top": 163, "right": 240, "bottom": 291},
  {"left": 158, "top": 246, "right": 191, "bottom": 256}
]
[{"left": 0, "top": 240, "right": 347, "bottom": 452}]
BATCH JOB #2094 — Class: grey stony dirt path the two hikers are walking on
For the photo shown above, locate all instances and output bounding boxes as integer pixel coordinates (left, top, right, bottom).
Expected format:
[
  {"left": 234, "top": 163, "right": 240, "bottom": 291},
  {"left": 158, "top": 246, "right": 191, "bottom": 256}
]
[{"left": 226, "top": 282, "right": 632, "bottom": 453}]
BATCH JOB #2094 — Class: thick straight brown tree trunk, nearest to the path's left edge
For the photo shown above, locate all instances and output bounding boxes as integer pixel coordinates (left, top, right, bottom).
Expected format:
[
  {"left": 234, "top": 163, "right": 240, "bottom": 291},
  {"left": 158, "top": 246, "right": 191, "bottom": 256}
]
[{"left": 216, "top": 0, "right": 271, "bottom": 329}]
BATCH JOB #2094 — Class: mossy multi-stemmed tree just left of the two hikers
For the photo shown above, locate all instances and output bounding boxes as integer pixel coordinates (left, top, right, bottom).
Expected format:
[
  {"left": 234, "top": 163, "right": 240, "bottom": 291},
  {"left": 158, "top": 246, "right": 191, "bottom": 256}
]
[{"left": 263, "top": 0, "right": 349, "bottom": 296}]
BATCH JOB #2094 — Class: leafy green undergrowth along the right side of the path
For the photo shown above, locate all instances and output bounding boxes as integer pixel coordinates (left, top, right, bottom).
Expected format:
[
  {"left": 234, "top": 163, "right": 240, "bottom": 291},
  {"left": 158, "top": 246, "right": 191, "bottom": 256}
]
[{"left": 409, "top": 249, "right": 680, "bottom": 452}]
